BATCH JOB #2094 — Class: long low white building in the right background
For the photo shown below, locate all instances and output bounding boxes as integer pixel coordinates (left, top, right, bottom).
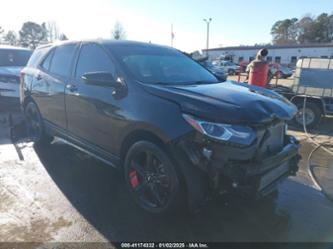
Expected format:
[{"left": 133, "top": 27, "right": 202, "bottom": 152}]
[{"left": 203, "top": 43, "right": 333, "bottom": 65}]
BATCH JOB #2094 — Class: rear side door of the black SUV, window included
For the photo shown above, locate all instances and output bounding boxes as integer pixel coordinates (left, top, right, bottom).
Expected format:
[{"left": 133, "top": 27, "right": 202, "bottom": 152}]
[{"left": 32, "top": 44, "right": 77, "bottom": 129}]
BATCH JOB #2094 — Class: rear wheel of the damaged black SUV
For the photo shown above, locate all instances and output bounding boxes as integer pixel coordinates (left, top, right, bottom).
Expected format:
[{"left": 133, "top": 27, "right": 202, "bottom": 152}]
[{"left": 24, "top": 102, "right": 53, "bottom": 145}]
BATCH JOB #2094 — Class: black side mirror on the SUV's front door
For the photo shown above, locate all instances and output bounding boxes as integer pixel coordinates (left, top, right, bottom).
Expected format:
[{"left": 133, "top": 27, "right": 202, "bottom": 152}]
[{"left": 81, "top": 72, "right": 121, "bottom": 87}]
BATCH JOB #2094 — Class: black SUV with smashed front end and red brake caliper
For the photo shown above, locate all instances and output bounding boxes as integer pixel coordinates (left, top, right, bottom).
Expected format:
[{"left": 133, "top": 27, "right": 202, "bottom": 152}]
[{"left": 21, "top": 40, "right": 299, "bottom": 213}]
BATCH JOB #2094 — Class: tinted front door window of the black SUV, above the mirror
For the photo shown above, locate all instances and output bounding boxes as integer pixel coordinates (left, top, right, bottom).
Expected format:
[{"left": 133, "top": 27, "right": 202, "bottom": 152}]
[{"left": 75, "top": 43, "right": 115, "bottom": 78}]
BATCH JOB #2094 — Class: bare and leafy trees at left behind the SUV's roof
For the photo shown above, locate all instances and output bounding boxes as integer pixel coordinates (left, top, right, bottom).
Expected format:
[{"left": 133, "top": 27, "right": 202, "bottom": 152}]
[{"left": 0, "top": 21, "right": 68, "bottom": 49}]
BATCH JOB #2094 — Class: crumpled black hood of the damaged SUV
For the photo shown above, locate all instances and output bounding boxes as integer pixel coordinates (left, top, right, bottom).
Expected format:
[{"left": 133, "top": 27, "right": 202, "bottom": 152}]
[{"left": 145, "top": 81, "right": 297, "bottom": 124}]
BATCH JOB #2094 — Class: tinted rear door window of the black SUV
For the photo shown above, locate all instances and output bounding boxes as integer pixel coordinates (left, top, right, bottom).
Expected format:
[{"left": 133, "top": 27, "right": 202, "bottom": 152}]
[{"left": 50, "top": 44, "right": 76, "bottom": 76}]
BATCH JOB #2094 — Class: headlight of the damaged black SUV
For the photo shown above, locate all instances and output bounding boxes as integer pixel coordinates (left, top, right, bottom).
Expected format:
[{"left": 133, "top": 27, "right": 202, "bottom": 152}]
[{"left": 183, "top": 114, "right": 256, "bottom": 145}]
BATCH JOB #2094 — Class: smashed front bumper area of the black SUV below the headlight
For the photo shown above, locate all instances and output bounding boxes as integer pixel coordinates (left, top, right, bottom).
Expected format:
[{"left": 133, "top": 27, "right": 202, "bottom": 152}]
[{"left": 172, "top": 127, "right": 300, "bottom": 201}]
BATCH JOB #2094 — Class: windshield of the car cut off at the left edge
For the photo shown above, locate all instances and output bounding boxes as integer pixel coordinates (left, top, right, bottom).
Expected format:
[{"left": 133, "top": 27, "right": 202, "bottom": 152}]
[{"left": 0, "top": 49, "right": 31, "bottom": 67}]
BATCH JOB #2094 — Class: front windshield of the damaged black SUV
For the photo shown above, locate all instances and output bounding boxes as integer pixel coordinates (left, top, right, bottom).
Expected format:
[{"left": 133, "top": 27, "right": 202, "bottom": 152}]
[{"left": 112, "top": 46, "right": 218, "bottom": 85}]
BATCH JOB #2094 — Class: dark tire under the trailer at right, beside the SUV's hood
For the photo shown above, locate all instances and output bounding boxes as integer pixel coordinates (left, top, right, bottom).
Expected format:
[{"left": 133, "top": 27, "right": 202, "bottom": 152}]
[{"left": 294, "top": 101, "right": 322, "bottom": 128}]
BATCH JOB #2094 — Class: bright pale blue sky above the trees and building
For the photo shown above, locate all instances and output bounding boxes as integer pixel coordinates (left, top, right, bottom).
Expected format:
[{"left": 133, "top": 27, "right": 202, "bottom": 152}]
[{"left": 0, "top": 0, "right": 333, "bottom": 52}]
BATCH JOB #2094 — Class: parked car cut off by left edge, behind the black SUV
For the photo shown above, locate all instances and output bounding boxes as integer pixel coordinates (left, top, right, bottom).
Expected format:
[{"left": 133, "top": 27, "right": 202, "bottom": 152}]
[{"left": 0, "top": 45, "right": 32, "bottom": 106}]
